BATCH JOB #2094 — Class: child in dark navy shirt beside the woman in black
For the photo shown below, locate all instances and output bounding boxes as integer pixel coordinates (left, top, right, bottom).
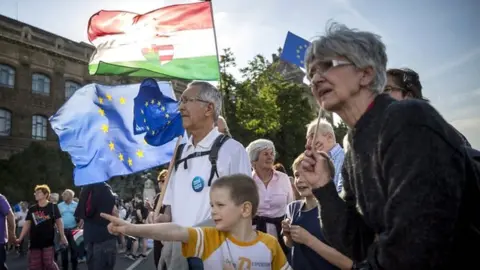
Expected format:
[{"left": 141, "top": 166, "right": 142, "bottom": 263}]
[{"left": 282, "top": 152, "right": 352, "bottom": 270}]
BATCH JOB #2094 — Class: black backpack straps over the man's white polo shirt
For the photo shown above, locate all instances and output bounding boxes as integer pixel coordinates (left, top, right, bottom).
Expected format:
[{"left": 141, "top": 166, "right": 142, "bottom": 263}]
[{"left": 175, "top": 134, "right": 230, "bottom": 186}]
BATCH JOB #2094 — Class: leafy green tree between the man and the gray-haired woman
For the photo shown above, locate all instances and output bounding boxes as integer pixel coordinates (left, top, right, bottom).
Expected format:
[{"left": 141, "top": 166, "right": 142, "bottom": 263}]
[{"left": 221, "top": 50, "right": 314, "bottom": 174}]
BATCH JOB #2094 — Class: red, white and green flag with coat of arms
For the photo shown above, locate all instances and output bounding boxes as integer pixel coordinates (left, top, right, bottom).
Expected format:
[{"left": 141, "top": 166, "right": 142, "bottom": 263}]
[{"left": 88, "top": 2, "right": 220, "bottom": 81}]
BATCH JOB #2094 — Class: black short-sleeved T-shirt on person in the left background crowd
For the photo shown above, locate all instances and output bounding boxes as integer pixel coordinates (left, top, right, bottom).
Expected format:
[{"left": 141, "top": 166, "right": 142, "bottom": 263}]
[{"left": 26, "top": 203, "right": 61, "bottom": 249}]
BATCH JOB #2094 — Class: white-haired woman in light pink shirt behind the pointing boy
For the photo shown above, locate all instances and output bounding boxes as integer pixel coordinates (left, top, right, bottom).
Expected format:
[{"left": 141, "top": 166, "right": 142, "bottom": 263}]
[{"left": 247, "top": 139, "right": 293, "bottom": 253}]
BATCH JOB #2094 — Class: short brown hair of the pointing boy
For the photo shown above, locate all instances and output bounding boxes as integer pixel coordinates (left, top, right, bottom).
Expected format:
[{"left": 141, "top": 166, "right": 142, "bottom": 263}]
[{"left": 211, "top": 174, "right": 260, "bottom": 217}]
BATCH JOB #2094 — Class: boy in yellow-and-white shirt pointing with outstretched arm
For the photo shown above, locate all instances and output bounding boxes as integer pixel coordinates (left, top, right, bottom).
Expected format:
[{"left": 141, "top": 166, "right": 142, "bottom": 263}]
[{"left": 101, "top": 174, "right": 290, "bottom": 270}]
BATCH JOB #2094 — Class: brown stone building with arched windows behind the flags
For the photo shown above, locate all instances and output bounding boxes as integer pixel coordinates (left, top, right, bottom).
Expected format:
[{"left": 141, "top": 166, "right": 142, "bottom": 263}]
[{"left": 0, "top": 15, "right": 186, "bottom": 159}]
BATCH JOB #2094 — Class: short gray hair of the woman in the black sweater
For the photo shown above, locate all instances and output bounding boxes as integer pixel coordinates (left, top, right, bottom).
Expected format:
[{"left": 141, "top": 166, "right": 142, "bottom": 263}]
[{"left": 305, "top": 22, "right": 388, "bottom": 93}]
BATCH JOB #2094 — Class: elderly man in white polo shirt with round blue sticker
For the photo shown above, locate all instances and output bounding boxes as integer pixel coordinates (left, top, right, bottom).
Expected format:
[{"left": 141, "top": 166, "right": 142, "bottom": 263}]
[{"left": 155, "top": 81, "right": 251, "bottom": 270}]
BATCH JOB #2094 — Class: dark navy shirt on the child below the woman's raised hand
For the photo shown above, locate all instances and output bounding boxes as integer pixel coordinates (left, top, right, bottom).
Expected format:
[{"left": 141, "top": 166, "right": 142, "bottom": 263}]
[{"left": 287, "top": 201, "right": 338, "bottom": 270}]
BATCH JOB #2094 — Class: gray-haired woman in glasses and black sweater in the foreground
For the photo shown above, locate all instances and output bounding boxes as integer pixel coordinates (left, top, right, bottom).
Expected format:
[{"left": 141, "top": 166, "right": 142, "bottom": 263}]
[{"left": 300, "top": 24, "right": 480, "bottom": 270}]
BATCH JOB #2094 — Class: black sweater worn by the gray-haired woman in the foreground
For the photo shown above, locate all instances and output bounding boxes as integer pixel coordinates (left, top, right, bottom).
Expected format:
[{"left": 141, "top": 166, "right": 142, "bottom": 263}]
[{"left": 314, "top": 95, "right": 480, "bottom": 270}]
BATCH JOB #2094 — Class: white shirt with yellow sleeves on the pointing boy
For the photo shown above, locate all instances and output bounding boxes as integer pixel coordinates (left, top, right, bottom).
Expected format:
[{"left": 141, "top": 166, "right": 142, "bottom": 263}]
[{"left": 182, "top": 227, "right": 291, "bottom": 270}]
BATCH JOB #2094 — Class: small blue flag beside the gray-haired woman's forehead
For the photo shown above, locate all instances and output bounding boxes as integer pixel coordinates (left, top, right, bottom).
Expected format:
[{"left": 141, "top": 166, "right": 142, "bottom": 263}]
[{"left": 280, "top": 32, "right": 310, "bottom": 68}]
